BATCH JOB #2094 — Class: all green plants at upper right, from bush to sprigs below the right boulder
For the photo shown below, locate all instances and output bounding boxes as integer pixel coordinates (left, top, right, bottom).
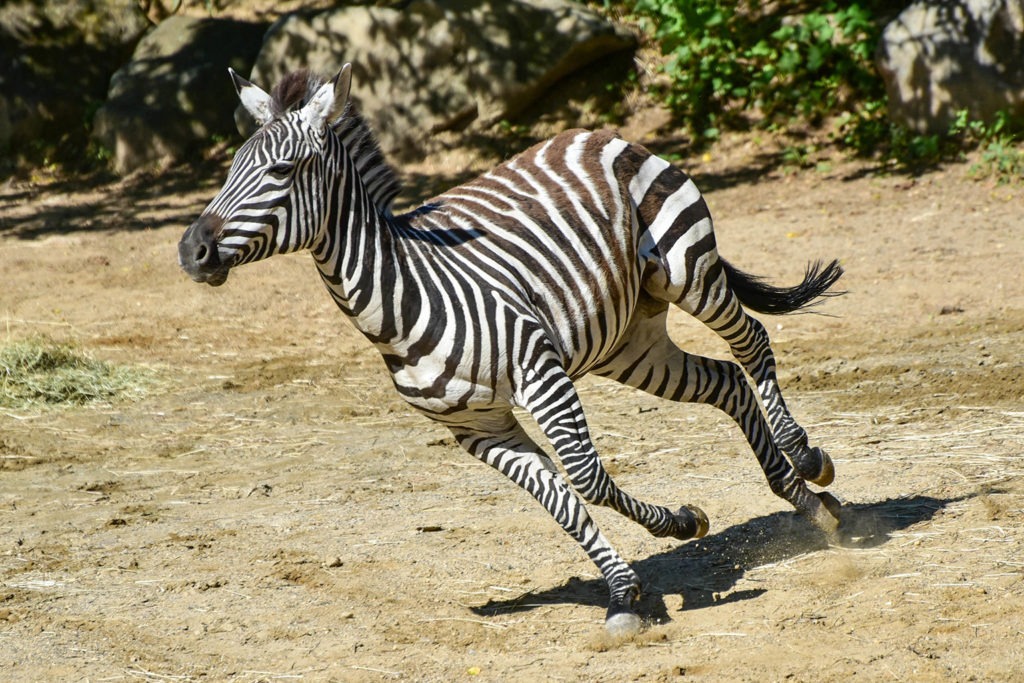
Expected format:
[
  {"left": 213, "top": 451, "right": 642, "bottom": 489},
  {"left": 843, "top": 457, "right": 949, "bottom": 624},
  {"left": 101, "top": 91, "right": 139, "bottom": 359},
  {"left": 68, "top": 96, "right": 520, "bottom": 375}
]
[{"left": 604, "top": 0, "right": 1024, "bottom": 181}]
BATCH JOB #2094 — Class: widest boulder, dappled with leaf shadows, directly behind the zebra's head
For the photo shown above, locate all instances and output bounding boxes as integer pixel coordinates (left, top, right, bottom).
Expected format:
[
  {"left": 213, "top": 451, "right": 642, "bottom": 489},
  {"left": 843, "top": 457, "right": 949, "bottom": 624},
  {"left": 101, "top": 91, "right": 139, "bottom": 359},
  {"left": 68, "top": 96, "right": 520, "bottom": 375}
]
[{"left": 242, "top": 0, "right": 636, "bottom": 159}]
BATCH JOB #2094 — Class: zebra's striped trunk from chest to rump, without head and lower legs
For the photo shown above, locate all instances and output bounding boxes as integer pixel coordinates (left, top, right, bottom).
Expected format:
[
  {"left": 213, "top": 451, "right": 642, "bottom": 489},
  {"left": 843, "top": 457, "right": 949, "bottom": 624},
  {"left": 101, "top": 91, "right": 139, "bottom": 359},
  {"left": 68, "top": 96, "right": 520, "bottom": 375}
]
[{"left": 313, "top": 130, "right": 721, "bottom": 419}]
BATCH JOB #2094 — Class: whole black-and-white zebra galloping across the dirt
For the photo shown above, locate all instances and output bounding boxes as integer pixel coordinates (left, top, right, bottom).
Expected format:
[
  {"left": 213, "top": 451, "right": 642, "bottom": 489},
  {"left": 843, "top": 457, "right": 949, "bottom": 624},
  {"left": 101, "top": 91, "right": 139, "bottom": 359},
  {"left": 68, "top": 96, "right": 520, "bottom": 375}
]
[{"left": 178, "top": 65, "right": 842, "bottom": 632}]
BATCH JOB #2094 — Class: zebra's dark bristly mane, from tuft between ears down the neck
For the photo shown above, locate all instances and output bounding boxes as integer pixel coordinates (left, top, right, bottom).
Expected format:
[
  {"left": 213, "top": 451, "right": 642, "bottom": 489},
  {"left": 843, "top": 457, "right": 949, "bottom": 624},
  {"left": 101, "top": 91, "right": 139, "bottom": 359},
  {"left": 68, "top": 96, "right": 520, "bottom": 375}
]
[{"left": 270, "top": 69, "right": 401, "bottom": 215}]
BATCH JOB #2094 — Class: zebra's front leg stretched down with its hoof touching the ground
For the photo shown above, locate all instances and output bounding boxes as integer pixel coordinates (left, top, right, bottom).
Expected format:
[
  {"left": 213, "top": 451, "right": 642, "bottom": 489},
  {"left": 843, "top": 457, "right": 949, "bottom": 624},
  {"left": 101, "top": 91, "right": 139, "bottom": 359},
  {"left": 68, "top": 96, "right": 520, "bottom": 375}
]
[{"left": 451, "top": 415, "right": 642, "bottom": 636}]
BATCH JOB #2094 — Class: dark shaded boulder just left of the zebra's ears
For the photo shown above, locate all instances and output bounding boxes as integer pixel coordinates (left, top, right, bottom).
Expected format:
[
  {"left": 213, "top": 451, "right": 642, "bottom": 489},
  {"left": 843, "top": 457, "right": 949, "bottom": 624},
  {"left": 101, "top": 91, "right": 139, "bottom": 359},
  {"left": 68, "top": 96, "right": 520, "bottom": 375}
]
[{"left": 92, "top": 16, "right": 266, "bottom": 173}]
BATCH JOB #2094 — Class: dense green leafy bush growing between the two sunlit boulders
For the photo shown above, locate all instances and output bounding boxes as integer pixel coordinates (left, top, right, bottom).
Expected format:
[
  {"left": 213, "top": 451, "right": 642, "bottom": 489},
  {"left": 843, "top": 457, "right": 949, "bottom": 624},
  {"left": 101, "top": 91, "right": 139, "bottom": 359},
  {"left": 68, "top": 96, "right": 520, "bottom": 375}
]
[{"left": 634, "top": 0, "right": 884, "bottom": 139}]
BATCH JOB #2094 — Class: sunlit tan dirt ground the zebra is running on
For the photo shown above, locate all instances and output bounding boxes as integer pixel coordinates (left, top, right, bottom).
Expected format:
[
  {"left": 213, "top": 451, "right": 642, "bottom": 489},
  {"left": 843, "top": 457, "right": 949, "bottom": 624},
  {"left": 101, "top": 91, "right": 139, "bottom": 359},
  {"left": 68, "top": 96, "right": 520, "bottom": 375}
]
[{"left": 0, "top": 136, "right": 1024, "bottom": 681}]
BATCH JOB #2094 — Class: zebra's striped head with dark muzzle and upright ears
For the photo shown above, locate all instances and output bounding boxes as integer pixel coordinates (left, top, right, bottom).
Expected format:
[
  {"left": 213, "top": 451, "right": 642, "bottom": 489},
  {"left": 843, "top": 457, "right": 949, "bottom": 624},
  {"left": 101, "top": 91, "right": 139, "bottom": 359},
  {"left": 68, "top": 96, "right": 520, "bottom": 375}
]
[{"left": 178, "top": 65, "right": 352, "bottom": 287}]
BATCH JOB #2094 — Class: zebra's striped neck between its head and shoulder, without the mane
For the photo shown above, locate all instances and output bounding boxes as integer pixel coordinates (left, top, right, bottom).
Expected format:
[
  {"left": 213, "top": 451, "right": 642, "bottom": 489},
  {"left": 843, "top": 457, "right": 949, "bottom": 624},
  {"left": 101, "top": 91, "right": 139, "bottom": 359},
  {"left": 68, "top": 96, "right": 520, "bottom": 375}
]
[{"left": 311, "top": 155, "right": 401, "bottom": 343}]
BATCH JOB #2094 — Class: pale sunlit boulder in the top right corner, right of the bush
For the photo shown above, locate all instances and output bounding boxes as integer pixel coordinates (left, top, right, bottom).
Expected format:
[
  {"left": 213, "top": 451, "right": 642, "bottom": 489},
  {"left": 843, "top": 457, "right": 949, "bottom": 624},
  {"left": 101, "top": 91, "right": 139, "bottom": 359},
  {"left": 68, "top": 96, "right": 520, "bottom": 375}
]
[{"left": 877, "top": 0, "right": 1024, "bottom": 133}]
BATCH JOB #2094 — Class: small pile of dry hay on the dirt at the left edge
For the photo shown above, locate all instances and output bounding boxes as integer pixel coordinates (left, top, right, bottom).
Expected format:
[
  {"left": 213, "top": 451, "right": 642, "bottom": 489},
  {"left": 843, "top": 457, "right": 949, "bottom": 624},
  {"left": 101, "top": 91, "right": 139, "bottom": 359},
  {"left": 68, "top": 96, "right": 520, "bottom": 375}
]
[{"left": 0, "top": 337, "right": 153, "bottom": 408}]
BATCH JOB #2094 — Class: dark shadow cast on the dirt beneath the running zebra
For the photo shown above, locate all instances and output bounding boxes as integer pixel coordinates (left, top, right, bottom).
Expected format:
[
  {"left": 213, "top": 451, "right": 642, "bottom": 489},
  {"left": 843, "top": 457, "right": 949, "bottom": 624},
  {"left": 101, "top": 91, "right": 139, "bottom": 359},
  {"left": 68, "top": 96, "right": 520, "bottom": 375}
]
[{"left": 471, "top": 496, "right": 964, "bottom": 624}]
